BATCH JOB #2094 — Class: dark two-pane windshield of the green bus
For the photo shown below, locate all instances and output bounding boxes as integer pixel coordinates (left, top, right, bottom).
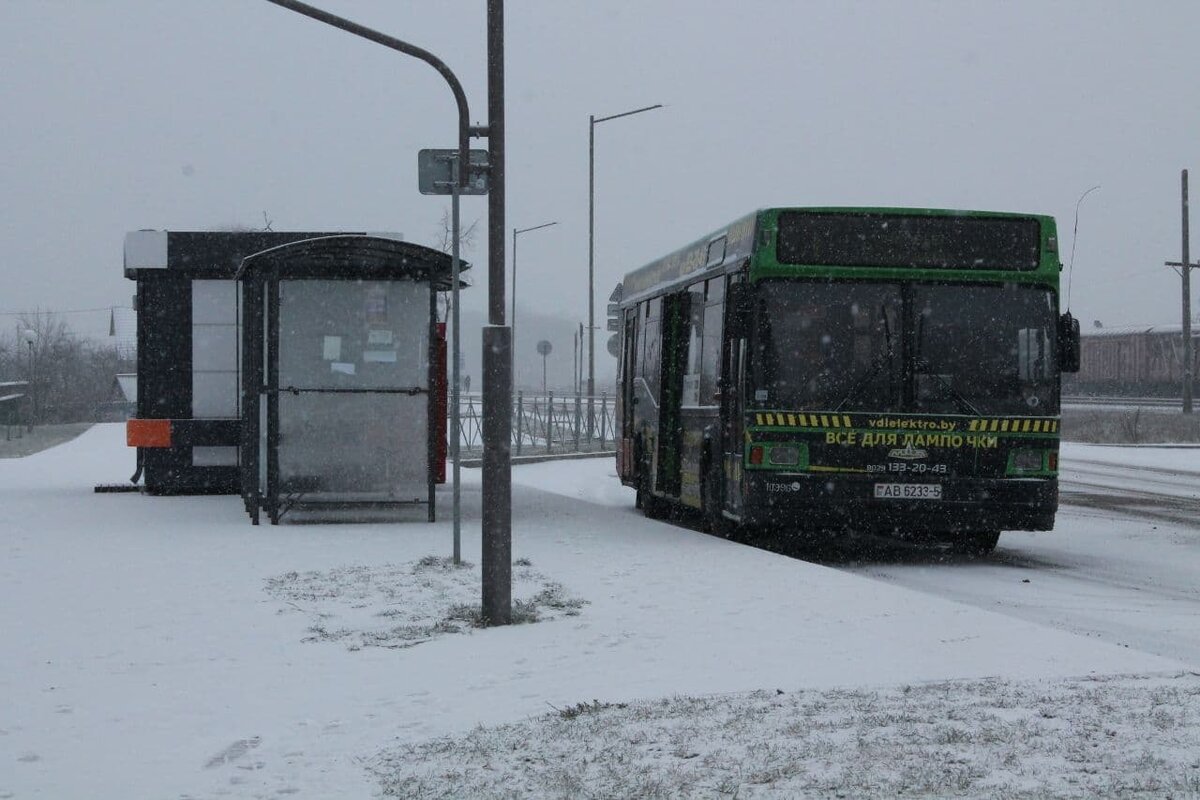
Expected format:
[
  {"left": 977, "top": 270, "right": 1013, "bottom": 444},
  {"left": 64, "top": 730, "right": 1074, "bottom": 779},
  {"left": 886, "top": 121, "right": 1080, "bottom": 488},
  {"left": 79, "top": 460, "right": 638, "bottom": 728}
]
[{"left": 749, "top": 279, "right": 1058, "bottom": 416}]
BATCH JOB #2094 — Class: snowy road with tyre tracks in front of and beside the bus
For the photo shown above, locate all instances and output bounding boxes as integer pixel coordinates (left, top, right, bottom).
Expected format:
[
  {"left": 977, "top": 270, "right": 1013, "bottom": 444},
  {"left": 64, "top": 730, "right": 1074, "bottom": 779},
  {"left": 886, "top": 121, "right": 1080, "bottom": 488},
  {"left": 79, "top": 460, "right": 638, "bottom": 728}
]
[{"left": 827, "top": 444, "right": 1200, "bottom": 664}]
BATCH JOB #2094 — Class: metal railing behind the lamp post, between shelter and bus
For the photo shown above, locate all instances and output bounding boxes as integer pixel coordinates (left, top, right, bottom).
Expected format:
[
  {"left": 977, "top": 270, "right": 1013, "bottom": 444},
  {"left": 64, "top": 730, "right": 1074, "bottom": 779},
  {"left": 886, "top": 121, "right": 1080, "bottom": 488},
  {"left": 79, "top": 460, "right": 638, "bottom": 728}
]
[{"left": 458, "top": 392, "right": 617, "bottom": 458}]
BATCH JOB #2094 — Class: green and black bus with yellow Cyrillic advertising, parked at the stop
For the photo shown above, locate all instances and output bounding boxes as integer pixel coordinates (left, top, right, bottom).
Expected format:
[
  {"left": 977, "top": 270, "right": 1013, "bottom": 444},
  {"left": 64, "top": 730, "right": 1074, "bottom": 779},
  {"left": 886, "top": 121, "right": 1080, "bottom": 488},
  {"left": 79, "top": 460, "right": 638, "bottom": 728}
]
[{"left": 617, "top": 207, "right": 1079, "bottom": 552}]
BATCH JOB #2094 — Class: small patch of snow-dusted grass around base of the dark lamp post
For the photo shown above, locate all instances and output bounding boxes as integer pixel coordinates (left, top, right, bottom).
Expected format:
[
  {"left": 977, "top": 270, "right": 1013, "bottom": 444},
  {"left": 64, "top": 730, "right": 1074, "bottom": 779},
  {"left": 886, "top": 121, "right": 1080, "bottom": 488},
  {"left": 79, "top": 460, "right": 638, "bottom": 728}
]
[{"left": 266, "top": 555, "right": 586, "bottom": 650}]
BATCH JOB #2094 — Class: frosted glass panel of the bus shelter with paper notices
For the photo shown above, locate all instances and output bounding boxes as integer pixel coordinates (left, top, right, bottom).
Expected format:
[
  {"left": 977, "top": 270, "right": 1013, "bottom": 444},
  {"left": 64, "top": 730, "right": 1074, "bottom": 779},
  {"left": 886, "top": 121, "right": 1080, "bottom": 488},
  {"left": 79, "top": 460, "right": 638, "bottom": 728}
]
[{"left": 278, "top": 279, "right": 430, "bottom": 501}]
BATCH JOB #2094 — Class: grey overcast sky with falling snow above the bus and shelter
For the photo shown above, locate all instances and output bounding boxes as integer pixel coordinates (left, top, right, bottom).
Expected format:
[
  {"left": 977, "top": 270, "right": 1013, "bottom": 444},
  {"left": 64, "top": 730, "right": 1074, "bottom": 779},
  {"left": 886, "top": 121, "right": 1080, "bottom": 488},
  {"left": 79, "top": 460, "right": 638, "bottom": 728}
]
[{"left": 0, "top": 0, "right": 1200, "bottom": 340}]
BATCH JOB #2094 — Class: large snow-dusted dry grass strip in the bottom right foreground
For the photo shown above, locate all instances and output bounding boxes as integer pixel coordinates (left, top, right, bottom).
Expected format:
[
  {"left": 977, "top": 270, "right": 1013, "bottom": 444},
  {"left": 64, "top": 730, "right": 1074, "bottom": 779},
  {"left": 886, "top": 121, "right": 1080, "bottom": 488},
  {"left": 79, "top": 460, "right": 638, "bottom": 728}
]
[{"left": 372, "top": 673, "right": 1200, "bottom": 800}]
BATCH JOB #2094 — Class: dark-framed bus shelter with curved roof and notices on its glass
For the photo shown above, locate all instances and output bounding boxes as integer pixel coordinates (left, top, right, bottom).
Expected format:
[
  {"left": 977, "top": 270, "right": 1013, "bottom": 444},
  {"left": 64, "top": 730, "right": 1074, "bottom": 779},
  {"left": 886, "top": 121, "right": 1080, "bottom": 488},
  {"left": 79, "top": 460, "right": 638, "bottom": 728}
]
[{"left": 236, "top": 235, "right": 466, "bottom": 524}]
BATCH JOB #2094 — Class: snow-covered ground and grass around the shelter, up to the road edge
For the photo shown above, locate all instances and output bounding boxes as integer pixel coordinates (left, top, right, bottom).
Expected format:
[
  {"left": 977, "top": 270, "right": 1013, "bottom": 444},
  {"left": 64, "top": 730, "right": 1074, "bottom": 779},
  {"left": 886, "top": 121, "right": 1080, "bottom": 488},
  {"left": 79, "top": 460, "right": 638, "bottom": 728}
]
[{"left": 0, "top": 426, "right": 1200, "bottom": 798}]
